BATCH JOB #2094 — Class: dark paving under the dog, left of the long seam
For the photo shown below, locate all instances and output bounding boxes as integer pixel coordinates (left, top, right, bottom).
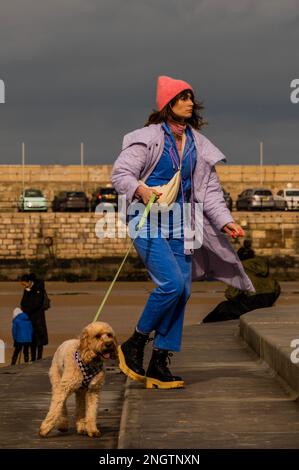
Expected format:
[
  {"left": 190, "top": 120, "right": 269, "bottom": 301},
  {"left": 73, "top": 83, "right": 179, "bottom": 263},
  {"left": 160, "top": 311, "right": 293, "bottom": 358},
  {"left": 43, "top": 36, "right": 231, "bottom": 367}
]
[{"left": 0, "top": 359, "right": 125, "bottom": 449}]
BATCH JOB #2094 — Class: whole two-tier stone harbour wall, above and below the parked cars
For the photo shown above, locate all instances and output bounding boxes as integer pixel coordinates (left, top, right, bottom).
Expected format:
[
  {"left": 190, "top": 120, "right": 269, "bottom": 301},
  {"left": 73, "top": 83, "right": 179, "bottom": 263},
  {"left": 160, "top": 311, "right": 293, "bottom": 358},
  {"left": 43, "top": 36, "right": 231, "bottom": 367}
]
[{"left": 0, "top": 165, "right": 299, "bottom": 281}]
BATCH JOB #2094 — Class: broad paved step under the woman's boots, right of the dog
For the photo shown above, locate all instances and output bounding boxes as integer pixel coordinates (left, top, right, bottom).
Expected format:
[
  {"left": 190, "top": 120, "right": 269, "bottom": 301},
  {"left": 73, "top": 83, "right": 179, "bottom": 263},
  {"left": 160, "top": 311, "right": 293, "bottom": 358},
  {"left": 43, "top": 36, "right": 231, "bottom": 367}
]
[{"left": 119, "top": 322, "right": 299, "bottom": 449}]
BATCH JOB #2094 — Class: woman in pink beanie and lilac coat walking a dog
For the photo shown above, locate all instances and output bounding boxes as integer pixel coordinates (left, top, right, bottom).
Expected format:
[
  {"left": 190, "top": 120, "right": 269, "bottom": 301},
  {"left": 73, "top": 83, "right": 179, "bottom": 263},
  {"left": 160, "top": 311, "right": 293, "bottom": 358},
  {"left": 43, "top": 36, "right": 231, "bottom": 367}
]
[{"left": 112, "top": 76, "right": 254, "bottom": 389}]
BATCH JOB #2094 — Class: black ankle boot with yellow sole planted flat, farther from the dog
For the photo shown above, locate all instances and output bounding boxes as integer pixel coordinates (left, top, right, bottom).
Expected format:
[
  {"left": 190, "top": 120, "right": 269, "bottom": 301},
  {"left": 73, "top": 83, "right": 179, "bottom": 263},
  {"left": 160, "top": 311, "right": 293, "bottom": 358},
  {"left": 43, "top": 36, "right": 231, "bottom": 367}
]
[{"left": 146, "top": 349, "right": 184, "bottom": 388}]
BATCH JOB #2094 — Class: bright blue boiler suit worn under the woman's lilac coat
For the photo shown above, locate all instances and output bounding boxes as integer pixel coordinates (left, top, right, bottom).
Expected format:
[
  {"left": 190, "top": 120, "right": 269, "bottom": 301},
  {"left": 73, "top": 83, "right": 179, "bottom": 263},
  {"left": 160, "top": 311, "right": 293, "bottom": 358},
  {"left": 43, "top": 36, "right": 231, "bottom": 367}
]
[{"left": 129, "top": 123, "right": 196, "bottom": 351}]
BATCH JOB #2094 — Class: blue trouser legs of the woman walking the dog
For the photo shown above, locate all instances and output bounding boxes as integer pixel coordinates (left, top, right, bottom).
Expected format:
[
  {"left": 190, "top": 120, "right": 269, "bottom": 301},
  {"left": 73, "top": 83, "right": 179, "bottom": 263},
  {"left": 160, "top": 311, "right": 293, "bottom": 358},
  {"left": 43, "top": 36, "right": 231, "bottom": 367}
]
[{"left": 134, "top": 221, "right": 192, "bottom": 351}]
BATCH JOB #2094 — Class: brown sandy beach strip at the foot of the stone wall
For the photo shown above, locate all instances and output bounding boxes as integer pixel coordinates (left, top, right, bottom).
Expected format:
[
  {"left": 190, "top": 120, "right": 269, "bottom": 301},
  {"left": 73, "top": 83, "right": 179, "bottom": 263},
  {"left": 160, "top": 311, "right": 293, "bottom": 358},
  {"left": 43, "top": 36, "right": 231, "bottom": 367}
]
[{"left": 0, "top": 282, "right": 299, "bottom": 366}]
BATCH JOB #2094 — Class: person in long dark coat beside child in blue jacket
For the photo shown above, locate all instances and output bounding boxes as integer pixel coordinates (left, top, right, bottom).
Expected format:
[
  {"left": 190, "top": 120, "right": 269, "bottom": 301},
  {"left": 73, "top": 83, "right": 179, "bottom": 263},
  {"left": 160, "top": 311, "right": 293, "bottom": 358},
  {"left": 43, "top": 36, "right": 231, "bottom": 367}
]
[{"left": 21, "top": 273, "right": 48, "bottom": 361}]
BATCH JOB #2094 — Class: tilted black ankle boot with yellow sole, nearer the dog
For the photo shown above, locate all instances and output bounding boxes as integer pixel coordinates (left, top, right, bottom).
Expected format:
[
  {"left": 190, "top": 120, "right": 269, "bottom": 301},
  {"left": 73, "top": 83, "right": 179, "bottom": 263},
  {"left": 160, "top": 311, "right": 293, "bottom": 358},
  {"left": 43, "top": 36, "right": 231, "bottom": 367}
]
[{"left": 118, "top": 331, "right": 149, "bottom": 382}]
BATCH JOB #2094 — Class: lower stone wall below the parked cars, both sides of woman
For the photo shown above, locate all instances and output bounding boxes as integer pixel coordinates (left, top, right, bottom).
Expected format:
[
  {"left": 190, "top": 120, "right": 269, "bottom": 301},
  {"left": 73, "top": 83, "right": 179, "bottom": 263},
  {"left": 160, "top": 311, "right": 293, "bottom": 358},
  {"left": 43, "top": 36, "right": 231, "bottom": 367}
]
[{"left": 0, "top": 212, "right": 299, "bottom": 280}]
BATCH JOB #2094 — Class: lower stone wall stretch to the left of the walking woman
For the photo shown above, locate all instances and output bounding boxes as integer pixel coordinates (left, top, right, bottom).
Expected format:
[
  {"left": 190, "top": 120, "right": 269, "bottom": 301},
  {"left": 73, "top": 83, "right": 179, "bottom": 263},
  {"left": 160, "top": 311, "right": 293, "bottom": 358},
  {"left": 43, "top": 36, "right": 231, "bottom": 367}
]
[{"left": 0, "top": 212, "right": 145, "bottom": 281}]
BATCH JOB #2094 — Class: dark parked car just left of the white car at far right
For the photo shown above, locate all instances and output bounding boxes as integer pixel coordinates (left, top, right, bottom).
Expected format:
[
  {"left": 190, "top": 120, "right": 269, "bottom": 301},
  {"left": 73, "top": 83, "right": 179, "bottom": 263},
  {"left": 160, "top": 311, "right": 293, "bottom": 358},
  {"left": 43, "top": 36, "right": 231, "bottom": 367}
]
[{"left": 236, "top": 188, "right": 274, "bottom": 211}]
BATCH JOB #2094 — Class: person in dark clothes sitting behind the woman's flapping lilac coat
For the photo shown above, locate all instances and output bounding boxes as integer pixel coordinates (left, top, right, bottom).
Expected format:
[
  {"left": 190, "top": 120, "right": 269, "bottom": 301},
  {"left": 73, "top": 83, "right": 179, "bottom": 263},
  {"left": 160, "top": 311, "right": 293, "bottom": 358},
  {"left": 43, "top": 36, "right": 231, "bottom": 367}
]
[{"left": 202, "top": 240, "right": 281, "bottom": 323}]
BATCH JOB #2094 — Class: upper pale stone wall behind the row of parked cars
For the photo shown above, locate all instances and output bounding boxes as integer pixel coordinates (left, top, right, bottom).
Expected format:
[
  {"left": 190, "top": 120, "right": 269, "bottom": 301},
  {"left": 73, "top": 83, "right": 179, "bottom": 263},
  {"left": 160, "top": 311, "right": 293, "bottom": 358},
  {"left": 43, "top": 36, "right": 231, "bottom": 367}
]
[{"left": 0, "top": 164, "right": 299, "bottom": 210}]
